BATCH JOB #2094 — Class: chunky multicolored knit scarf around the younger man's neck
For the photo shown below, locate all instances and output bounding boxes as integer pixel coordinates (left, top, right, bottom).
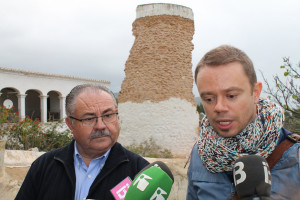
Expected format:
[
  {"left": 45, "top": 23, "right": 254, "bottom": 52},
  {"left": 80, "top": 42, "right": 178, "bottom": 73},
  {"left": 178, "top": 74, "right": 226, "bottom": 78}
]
[{"left": 197, "top": 98, "right": 284, "bottom": 173}]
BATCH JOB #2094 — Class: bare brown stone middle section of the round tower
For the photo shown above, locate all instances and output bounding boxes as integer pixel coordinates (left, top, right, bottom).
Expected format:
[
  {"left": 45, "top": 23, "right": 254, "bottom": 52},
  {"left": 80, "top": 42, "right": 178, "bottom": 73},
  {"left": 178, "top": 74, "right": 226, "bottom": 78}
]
[{"left": 119, "top": 15, "right": 195, "bottom": 105}]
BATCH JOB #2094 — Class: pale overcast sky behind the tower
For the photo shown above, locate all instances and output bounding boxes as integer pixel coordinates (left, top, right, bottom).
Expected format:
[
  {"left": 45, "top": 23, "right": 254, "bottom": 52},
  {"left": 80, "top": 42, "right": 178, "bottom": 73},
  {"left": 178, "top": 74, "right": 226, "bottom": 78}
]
[{"left": 0, "top": 0, "right": 300, "bottom": 96}]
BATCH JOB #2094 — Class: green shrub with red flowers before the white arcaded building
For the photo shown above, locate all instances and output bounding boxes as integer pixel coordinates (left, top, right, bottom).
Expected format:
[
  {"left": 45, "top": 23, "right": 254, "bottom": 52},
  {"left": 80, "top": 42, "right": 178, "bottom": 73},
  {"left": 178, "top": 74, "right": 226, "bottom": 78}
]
[{"left": 0, "top": 105, "right": 72, "bottom": 151}]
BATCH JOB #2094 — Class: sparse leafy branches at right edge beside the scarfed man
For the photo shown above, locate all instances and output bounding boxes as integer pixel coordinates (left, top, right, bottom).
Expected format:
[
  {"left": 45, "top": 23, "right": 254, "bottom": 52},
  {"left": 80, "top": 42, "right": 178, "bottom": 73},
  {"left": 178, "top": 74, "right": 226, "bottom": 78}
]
[{"left": 262, "top": 57, "right": 300, "bottom": 116}]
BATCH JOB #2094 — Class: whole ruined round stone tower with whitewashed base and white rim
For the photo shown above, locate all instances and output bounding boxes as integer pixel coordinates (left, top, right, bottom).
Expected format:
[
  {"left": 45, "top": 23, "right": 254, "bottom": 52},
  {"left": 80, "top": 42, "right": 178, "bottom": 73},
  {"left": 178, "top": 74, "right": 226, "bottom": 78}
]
[{"left": 118, "top": 4, "right": 199, "bottom": 157}]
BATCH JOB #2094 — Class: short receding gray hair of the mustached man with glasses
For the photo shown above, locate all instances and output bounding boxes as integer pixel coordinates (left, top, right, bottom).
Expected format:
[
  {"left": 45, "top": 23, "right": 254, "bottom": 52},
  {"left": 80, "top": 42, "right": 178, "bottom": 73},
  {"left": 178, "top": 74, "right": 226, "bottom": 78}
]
[{"left": 66, "top": 84, "right": 118, "bottom": 117}]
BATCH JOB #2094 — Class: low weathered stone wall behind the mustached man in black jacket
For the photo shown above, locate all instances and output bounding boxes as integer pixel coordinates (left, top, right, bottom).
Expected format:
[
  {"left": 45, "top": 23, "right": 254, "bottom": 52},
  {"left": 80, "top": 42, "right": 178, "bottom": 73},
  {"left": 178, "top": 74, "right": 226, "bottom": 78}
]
[{"left": 0, "top": 150, "right": 187, "bottom": 200}]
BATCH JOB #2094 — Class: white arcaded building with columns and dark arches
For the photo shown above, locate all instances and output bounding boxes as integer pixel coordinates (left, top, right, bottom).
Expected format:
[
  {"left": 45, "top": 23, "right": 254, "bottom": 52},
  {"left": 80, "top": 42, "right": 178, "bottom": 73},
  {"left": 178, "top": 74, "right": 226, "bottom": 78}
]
[{"left": 0, "top": 67, "right": 110, "bottom": 122}]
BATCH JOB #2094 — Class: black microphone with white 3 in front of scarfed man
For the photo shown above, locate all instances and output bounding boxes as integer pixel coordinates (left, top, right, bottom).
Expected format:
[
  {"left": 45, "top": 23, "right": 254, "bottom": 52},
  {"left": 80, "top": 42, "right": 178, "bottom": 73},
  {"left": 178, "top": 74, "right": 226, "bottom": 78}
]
[{"left": 233, "top": 155, "right": 271, "bottom": 200}]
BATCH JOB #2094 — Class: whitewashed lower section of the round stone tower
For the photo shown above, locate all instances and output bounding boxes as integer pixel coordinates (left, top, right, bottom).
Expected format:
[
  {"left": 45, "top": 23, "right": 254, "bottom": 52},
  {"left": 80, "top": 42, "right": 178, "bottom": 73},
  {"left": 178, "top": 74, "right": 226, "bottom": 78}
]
[{"left": 119, "top": 98, "right": 199, "bottom": 157}]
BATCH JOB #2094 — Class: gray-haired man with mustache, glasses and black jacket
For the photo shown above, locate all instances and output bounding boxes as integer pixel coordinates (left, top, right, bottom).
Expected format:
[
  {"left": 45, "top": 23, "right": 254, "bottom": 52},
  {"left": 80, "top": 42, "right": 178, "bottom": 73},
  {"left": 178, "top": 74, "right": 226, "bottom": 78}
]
[{"left": 16, "top": 85, "right": 149, "bottom": 200}]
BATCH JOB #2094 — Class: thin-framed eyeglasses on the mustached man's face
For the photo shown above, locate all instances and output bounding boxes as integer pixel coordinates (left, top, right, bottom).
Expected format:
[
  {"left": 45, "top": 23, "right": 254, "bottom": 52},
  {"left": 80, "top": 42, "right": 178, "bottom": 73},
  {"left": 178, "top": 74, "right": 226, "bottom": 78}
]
[{"left": 70, "top": 112, "right": 118, "bottom": 127}]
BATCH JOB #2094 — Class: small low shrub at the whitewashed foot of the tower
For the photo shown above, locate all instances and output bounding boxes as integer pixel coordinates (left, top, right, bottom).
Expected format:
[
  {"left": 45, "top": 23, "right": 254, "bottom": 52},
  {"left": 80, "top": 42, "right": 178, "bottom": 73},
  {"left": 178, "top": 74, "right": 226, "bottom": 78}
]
[{"left": 125, "top": 137, "right": 173, "bottom": 158}]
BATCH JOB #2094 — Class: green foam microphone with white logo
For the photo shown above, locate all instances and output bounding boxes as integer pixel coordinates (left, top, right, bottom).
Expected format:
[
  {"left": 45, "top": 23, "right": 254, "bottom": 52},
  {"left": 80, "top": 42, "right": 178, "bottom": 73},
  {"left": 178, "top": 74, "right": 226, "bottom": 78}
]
[{"left": 124, "top": 161, "right": 174, "bottom": 200}]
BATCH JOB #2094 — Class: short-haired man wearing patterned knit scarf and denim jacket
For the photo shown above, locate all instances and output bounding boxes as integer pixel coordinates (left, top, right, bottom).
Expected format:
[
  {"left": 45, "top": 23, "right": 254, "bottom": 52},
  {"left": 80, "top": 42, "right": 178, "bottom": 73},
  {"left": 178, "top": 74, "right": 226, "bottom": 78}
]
[{"left": 187, "top": 45, "right": 300, "bottom": 200}]
